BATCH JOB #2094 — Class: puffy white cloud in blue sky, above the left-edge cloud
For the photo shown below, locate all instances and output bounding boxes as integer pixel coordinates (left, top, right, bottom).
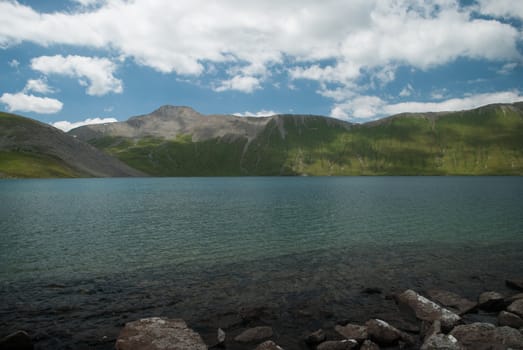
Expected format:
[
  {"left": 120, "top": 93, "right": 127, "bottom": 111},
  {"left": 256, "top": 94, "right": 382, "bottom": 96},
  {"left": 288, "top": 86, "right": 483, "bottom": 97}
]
[{"left": 31, "top": 55, "right": 123, "bottom": 96}]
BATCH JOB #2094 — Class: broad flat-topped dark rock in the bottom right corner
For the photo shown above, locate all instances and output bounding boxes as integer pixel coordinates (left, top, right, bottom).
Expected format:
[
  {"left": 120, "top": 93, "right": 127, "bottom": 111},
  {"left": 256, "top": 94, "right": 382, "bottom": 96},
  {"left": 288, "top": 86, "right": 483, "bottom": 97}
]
[{"left": 450, "top": 323, "right": 523, "bottom": 350}]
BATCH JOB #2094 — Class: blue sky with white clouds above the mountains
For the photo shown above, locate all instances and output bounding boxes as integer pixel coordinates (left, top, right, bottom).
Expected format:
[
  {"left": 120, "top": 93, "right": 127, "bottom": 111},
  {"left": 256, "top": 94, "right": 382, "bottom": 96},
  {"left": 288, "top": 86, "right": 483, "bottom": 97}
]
[{"left": 0, "top": 0, "right": 523, "bottom": 130}]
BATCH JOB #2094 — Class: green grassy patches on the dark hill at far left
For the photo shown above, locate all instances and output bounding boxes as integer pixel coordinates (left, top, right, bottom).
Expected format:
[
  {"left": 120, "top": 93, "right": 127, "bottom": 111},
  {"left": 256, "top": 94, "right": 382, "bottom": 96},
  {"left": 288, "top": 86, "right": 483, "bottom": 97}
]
[{"left": 0, "top": 112, "right": 85, "bottom": 178}]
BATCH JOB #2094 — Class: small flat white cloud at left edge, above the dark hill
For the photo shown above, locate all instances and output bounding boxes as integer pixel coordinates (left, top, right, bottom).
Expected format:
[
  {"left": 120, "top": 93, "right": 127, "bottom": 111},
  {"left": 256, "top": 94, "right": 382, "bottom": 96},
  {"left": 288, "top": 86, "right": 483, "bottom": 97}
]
[{"left": 0, "top": 92, "right": 63, "bottom": 114}]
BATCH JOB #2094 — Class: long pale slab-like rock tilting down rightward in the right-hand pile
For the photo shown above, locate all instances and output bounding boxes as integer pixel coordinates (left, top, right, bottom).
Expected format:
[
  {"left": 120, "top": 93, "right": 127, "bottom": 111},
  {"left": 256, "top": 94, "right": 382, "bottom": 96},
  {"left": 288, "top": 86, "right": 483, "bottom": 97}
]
[{"left": 395, "top": 289, "right": 461, "bottom": 331}]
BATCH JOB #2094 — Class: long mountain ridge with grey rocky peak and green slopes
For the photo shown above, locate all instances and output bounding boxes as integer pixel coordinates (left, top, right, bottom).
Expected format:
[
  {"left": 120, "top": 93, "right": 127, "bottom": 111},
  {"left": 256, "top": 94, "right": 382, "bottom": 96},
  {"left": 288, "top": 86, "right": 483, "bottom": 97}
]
[{"left": 70, "top": 103, "right": 523, "bottom": 176}]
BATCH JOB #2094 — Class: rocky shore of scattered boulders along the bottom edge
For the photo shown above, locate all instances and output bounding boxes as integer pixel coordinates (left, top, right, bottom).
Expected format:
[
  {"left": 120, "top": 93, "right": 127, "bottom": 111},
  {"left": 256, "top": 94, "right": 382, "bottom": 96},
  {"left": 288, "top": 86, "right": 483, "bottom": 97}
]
[{"left": 4, "top": 278, "right": 523, "bottom": 350}]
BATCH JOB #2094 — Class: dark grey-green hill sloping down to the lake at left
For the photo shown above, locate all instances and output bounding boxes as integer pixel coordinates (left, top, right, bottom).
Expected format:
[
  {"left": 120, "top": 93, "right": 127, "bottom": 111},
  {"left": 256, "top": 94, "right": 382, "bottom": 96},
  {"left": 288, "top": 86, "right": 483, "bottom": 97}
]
[{"left": 0, "top": 113, "right": 143, "bottom": 177}]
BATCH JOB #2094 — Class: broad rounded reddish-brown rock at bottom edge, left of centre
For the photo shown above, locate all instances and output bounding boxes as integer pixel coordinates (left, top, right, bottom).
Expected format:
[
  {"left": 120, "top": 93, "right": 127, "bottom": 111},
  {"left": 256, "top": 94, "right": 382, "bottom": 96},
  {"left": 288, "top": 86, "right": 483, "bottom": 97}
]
[{"left": 115, "top": 317, "right": 207, "bottom": 350}]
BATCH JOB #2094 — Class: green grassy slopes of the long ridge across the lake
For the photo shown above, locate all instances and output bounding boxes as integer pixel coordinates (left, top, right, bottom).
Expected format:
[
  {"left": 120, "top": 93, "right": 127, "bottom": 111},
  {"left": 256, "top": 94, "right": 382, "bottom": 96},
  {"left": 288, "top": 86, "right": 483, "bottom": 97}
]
[{"left": 93, "top": 106, "right": 523, "bottom": 176}]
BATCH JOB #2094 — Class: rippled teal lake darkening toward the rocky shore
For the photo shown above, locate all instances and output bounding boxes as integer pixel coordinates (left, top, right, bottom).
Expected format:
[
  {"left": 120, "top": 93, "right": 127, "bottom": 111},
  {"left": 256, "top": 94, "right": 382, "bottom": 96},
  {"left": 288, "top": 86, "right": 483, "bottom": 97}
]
[{"left": 0, "top": 177, "right": 523, "bottom": 349}]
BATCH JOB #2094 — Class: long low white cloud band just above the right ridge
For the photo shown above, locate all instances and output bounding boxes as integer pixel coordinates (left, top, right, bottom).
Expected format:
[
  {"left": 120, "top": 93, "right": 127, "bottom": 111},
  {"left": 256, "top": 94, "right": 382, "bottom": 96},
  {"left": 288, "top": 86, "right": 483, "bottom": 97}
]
[{"left": 331, "top": 91, "right": 523, "bottom": 121}]
